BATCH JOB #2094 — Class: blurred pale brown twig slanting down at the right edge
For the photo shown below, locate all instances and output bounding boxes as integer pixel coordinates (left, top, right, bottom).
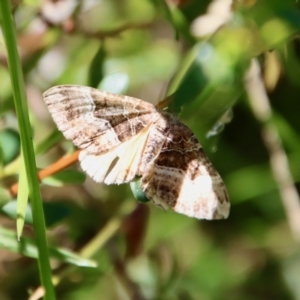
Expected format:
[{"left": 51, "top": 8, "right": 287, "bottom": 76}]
[{"left": 245, "top": 59, "right": 300, "bottom": 242}]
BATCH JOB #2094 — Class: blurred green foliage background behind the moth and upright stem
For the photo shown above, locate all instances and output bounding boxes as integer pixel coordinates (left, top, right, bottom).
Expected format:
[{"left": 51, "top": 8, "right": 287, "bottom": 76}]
[{"left": 0, "top": 0, "right": 300, "bottom": 300}]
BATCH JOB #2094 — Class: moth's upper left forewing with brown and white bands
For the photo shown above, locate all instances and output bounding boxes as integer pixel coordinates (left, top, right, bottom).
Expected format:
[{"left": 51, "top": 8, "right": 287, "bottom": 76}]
[{"left": 43, "top": 85, "right": 158, "bottom": 155}]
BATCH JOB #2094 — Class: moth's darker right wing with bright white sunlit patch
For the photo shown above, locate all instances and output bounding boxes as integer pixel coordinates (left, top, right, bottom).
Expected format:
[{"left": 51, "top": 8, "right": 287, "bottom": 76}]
[{"left": 141, "top": 112, "right": 230, "bottom": 220}]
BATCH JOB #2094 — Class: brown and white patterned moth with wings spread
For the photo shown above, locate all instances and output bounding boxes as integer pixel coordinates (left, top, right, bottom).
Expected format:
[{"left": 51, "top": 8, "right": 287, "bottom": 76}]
[{"left": 43, "top": 85, "right": 230, "bottom": 220}]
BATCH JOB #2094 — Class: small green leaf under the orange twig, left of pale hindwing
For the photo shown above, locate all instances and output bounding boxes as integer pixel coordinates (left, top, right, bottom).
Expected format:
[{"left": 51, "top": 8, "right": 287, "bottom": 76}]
[{"left": 42, "top": 170, "right": 86, "bottom": 186}]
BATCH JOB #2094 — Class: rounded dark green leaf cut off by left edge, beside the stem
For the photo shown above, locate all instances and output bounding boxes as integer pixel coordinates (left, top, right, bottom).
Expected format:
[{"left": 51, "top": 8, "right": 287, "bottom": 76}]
[{"left": 0, "top": 128, "right": 20, "bottom": 165}]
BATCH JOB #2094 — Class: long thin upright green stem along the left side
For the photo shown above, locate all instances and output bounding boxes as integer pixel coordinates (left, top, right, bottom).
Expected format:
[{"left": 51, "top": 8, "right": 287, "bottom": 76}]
[{"left": 0, "top": 0, "right": 55, "bottom": 300}]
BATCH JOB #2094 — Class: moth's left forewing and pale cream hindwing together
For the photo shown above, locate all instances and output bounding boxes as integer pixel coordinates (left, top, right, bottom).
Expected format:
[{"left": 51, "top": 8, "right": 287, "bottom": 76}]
[{"left": 44, "top": 85, "right": 160, "bottom": 184}]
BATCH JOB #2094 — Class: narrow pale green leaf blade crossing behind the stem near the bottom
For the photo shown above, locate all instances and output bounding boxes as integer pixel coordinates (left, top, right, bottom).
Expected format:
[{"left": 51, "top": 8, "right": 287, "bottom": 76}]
[{"left": 0, "top": 227, "right": 97, "bottom": 268}]
